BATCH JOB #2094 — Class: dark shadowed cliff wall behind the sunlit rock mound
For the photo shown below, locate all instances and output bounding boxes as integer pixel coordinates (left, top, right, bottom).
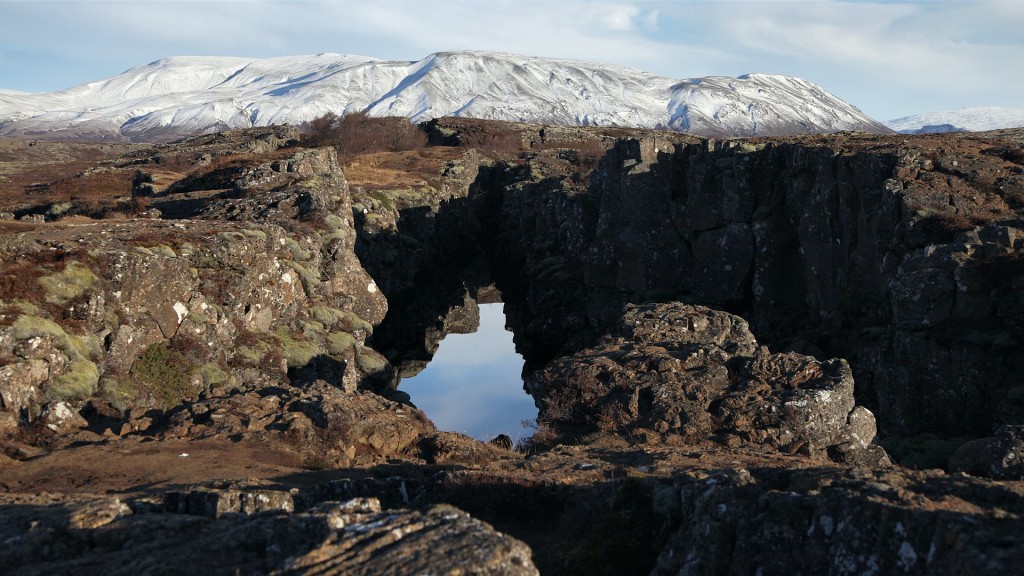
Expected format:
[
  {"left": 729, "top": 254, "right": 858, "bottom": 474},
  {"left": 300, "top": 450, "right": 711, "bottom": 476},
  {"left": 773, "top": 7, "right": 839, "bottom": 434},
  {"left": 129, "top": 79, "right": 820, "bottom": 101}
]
[{"left": 496, "top": 132, "right": 1024, "bottom": 435}]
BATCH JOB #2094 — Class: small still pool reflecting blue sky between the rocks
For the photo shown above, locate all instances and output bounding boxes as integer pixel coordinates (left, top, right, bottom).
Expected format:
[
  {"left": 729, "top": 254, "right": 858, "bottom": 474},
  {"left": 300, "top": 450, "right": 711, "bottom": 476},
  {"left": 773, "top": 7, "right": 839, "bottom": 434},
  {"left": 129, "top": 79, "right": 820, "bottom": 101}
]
[{"left": 400, "top": 303, "right": 537, "bottom": 441}]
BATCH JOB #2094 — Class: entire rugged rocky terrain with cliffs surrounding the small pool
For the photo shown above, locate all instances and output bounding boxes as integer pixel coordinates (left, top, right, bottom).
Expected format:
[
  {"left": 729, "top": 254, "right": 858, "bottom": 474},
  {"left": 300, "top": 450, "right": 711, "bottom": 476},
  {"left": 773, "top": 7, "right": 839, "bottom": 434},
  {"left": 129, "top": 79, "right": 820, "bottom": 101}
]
[{"left": 0, "top": 121, "right": 1024, "bottom": 574}]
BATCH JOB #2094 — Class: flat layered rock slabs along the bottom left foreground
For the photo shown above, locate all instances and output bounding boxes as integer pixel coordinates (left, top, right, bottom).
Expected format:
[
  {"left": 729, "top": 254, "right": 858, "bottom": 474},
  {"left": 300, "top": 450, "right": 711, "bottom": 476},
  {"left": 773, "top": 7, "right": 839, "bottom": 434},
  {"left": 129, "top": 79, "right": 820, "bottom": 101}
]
[{"left": 0, "top": 495, "right": 538, "bottom": 576}]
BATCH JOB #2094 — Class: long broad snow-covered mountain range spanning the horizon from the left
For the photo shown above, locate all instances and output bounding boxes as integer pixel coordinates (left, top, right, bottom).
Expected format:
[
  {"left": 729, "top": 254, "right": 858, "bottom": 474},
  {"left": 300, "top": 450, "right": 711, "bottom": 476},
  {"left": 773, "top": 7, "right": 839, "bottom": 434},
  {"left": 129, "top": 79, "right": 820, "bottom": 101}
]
[{"left": 0, "top": 51, "right": 889, "bottom": 140}]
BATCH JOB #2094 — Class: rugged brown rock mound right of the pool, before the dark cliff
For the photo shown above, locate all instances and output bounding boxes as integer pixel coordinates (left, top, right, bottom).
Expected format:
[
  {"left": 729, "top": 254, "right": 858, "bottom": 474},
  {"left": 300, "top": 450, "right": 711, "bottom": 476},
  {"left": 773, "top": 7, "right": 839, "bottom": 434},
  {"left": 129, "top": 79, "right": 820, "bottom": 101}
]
[{"left": 526, "top": 303, "right": 888, "bottom": 466}]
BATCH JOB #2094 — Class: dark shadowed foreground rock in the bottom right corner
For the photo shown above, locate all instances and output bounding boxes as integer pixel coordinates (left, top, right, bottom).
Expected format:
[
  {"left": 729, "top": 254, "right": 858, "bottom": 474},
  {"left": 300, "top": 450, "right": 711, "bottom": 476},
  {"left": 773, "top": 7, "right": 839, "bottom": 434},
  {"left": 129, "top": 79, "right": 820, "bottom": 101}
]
[{"left": 651, "top": 463, "right": 1024, "bottom": 575}]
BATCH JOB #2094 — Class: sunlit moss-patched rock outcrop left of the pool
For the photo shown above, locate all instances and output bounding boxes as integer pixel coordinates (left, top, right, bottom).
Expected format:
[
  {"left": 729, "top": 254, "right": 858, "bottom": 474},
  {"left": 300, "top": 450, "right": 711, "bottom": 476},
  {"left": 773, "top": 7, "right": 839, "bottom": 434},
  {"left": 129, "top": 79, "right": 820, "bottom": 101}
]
[{"left": 0, "top": 127, "right": 391, "bottom": 431}]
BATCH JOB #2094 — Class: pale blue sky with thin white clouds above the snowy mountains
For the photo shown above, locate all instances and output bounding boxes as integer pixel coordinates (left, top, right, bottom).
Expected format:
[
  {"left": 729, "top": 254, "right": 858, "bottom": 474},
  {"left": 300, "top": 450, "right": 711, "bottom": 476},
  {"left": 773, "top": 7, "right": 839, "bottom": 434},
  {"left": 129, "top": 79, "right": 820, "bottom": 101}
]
[{"left": 0, "top": 0, "right": 1024, "bottom": 120}]
